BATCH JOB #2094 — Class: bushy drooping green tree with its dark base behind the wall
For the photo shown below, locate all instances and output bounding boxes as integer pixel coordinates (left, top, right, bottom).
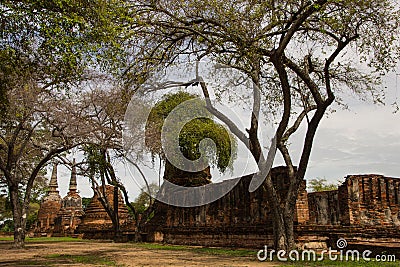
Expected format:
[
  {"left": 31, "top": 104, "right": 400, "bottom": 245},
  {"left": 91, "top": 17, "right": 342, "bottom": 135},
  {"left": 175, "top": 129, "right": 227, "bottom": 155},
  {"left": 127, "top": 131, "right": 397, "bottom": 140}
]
[{"left": 145, "top": 92, "right": 236, "bottom": 186}]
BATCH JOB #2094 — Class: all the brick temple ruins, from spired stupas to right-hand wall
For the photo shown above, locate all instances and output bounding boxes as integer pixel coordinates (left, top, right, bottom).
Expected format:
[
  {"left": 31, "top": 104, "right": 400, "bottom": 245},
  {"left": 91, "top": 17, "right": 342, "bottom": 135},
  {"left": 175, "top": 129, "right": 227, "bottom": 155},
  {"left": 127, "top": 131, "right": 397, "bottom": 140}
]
[{"left": 36, "top": 167, "right": 400, "bottom": 251}]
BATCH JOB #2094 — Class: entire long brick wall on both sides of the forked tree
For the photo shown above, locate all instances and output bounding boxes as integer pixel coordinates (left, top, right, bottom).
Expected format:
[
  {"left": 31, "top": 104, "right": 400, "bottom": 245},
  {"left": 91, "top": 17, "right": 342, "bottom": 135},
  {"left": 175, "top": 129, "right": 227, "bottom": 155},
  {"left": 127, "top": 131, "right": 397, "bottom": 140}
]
[{"left": 148, "top": 167, "right": 400, "bottom": 251}]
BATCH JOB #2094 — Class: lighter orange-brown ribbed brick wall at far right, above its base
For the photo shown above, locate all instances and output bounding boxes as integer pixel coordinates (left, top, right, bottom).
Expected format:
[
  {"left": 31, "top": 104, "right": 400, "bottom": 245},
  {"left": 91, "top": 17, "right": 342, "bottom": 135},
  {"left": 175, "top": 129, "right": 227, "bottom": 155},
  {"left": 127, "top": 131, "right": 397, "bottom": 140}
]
[{"left": 308, "top": 174, "right": 400, "bottom": 227}]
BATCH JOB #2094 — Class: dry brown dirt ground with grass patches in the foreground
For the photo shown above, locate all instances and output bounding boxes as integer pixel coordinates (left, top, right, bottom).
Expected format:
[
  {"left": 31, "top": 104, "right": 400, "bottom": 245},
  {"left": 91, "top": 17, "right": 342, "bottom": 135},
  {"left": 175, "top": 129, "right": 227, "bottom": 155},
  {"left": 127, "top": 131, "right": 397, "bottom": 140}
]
[{"left": 0, "top": 241, "right": 277, "bottom": 267}]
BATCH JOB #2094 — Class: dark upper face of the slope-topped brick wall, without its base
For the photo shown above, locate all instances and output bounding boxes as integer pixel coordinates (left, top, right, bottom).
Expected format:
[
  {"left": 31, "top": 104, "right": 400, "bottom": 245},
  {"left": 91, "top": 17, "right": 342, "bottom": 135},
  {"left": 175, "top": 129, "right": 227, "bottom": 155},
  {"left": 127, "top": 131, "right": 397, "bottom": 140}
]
[{"left": 150, "top": 168, "right": 308, "bottom": 227}]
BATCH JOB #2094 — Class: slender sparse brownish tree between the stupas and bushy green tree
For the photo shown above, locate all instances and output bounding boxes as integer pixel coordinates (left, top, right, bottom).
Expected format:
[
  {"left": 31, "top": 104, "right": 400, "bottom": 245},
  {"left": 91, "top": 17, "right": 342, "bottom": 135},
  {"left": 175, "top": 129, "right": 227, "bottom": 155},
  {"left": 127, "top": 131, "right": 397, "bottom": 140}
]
[{"left": 71, "top": 84, "right": 141, "bottom": 241}]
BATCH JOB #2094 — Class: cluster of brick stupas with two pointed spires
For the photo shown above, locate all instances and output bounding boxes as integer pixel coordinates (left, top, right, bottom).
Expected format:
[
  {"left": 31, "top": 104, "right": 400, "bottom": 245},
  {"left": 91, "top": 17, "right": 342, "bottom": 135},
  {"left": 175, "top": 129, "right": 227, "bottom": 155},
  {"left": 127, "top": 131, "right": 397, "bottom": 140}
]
[{"left": 34, "top": 161, "right": 130, "bottom": 239}]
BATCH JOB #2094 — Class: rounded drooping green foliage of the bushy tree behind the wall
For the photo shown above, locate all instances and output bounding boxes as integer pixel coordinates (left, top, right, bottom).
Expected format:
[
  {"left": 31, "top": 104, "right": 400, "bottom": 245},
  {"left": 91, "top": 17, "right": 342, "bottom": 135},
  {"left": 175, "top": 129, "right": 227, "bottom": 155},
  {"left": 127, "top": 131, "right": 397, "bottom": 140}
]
[{"left": 145, "top": 92, "right": 236, "bottom": 172}]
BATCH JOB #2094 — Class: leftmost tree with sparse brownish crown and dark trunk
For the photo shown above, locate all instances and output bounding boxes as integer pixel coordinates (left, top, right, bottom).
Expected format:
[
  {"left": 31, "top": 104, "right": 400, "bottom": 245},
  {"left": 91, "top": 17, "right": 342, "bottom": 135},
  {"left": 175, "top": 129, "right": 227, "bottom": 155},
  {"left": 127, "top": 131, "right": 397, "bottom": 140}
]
[{"left": 0, "top": 83, "right": 89, "bottom": 247}]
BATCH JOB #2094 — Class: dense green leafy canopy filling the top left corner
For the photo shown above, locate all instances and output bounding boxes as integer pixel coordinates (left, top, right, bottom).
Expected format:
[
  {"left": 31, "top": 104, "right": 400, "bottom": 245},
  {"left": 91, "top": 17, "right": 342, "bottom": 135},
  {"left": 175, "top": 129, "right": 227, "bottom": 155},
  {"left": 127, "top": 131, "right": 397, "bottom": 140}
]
[{"left": 0, "top": 0, "right": 126, "bottom": 110}]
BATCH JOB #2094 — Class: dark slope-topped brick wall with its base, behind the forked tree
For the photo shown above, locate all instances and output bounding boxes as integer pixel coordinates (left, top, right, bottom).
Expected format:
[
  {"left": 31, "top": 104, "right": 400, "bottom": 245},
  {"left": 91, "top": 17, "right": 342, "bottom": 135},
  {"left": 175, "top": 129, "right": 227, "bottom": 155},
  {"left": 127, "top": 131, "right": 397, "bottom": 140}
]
[{"left": 148, "top": 167, "right": 309, "bottom": 247}]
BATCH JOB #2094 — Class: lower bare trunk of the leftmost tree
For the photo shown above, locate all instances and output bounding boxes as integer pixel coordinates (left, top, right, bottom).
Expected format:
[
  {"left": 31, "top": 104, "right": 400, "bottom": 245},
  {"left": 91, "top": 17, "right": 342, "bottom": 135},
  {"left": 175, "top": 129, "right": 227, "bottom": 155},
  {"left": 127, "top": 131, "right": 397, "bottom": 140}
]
[{"left": 9, "top": 186, "right": 27, "bottom": 248}]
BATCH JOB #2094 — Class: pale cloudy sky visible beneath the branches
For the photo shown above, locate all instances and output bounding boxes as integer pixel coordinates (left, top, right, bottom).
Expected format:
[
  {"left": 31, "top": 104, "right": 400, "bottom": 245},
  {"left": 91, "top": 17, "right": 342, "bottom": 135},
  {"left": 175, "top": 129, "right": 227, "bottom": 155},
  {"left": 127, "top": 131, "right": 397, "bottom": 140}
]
[{"left": 54, "top": 68, "right": 400, "bottom": 201}]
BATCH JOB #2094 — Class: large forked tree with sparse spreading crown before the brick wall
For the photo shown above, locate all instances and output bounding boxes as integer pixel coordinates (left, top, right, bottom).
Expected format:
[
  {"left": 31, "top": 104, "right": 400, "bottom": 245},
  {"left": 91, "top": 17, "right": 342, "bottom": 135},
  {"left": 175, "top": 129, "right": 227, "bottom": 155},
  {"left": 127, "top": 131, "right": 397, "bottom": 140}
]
[{"left": 130, "top": 0, "right": 400, "bottom": 251}]
